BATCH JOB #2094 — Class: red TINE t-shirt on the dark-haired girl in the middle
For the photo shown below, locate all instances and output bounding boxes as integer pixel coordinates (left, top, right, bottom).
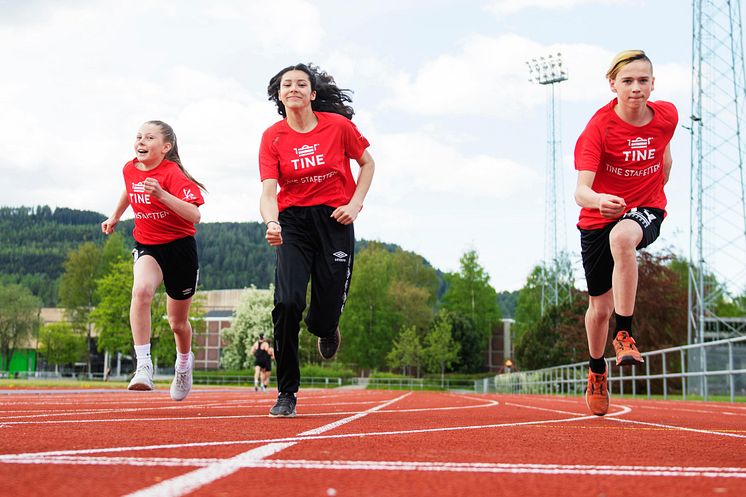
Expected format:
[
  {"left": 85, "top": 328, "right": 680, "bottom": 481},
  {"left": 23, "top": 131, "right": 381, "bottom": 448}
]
[{"left": 259, "top": 112, "right": 370, "bottom": 211}]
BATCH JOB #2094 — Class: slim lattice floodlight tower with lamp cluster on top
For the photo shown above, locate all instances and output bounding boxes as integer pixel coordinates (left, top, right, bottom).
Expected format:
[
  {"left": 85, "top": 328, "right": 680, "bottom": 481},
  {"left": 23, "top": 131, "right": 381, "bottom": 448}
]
[{"left": 526, "top": 53, "right": 572, "bottom": 314}]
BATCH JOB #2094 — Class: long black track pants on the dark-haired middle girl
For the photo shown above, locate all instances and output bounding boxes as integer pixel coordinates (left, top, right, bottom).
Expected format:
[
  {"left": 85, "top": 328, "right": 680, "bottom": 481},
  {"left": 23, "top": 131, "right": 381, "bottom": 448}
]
[{"left": 272, "top": 205, "right": 355, "bottom": 393}]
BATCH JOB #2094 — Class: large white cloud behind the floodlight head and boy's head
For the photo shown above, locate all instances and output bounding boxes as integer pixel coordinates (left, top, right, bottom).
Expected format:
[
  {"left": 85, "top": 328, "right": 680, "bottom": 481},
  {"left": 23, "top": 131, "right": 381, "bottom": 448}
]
[{"left": 379, "top": 34, "right": 689, "bottom": 121}]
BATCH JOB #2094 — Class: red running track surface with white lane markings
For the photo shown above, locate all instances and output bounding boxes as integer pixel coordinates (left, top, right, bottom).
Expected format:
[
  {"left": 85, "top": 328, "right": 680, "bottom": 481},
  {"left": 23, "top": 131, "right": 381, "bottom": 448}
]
[{"left": 0, "top": 388, "right": 746, "bottom": 497}]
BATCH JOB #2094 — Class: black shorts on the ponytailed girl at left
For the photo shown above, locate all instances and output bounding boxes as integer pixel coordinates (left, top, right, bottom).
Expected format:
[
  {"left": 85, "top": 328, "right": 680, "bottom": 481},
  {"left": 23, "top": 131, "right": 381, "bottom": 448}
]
[{"left": 132, "top": 236, "right": 199, "bottom": 300}]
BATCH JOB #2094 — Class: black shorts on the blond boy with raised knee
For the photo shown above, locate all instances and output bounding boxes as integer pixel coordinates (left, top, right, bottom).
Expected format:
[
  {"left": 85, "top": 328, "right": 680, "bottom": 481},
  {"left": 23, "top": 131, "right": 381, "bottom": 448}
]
[{"left": 580, "top": 207, "right": 664, "bottom": 297}]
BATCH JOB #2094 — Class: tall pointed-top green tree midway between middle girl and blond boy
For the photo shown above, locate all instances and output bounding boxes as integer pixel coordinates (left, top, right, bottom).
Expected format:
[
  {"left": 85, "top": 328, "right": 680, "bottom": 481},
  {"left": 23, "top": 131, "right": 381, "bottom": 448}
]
[{"left": 443, "top": 250, "right": 501, "bottom": 372}]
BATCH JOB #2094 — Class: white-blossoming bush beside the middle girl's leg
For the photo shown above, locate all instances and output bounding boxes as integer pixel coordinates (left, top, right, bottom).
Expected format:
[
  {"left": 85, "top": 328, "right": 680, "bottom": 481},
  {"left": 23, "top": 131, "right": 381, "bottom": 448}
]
[{"left": 221, "top": 287, "right": 274, "bottom": 369}]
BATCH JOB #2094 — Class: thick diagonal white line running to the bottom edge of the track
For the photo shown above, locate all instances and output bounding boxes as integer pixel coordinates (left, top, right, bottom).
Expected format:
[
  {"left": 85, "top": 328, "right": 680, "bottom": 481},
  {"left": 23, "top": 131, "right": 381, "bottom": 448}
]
[{"left": 125, "top": 392, "right": 411, "bottom": 497}]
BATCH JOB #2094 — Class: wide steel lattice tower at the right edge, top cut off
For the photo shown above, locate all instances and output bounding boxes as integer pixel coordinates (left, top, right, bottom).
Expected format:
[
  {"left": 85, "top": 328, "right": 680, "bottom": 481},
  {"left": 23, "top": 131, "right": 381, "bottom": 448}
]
[{"left": 687, "top": 0, "right": 746, "bottom": 343}]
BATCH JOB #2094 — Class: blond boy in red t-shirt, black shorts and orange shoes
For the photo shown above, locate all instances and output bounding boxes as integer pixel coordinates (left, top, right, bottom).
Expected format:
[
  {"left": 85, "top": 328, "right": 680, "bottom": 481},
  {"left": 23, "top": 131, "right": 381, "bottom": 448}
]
[{"left": 575, "top": 50, "right": 678, "bottom": 416}]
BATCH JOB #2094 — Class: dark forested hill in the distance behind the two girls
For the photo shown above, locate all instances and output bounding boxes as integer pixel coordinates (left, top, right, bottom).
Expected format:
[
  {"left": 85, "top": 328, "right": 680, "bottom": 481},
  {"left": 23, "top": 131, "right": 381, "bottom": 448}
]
[{"left": 0, "top": 206, "right": 404, "bottom": 306}]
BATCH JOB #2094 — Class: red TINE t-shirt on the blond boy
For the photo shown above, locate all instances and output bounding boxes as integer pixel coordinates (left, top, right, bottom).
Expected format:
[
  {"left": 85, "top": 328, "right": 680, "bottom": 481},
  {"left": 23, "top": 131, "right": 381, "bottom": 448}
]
[{"left": 575, "top": 98, "right": 679, "bottom": 229}]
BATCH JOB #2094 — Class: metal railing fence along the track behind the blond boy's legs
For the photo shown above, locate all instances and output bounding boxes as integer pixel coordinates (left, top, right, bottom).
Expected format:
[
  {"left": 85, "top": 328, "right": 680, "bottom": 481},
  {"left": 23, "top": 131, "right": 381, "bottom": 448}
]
[{"left": 475, "top": 337, "right": 746, "bottom": 402}]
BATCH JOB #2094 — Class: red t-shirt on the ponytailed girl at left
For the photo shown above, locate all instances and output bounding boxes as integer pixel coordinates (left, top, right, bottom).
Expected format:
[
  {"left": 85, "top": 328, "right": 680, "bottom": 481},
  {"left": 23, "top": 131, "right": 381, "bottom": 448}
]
[{"left": 122, "top": 159, "right": 205, "bottom": 245}]
